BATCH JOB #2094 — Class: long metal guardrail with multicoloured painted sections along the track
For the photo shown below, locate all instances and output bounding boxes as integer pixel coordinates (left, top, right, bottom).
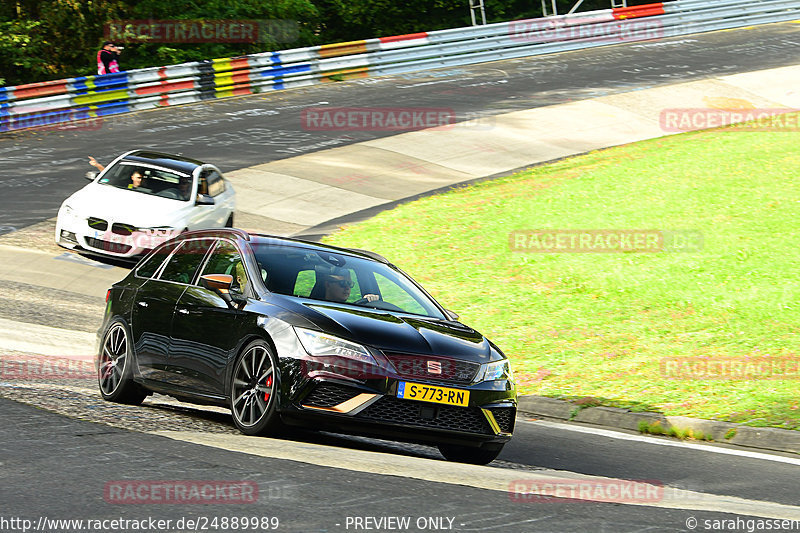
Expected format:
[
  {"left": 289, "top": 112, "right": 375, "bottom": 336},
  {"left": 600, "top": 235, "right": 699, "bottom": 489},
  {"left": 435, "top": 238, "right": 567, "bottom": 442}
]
[{"left": 0, "top": 0, "right": 800, "bottom": 131}]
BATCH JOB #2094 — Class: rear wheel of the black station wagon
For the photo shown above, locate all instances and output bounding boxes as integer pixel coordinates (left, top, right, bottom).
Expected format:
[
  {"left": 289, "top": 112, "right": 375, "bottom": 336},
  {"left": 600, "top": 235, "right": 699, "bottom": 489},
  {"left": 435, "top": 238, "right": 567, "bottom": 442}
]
[{"left": 97, "top": 319, "right": 148, "bottom": 405}]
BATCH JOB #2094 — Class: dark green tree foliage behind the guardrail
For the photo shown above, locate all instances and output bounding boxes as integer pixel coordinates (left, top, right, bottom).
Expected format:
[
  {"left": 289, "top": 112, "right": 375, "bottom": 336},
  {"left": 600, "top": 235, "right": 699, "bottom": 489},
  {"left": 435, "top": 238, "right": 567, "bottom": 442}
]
[{"left": 0, "top": 0, "right": 648, "bottom": 85}]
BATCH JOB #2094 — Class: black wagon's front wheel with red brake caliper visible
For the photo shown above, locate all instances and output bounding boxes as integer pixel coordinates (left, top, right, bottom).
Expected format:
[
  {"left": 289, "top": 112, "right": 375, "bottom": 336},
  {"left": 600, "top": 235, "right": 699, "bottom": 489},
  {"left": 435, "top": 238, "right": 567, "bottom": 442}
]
[{"left": 229, "top": 340, "right": 284, "bottom": 435}]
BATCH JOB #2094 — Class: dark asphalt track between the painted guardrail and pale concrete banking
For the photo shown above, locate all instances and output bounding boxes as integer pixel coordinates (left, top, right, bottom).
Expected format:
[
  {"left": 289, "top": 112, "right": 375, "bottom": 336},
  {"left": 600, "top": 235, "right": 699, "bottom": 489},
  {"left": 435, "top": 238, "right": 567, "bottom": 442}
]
[{"left": 0, "top": 23, "right": 800, "bottom": 234}]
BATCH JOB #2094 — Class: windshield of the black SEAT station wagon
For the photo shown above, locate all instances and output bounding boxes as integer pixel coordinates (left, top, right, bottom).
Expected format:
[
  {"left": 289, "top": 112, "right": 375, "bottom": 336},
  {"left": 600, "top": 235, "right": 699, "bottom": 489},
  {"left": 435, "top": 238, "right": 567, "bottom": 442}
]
[{"left": 253, "top": 243, "right": 445, "bottom": 319}]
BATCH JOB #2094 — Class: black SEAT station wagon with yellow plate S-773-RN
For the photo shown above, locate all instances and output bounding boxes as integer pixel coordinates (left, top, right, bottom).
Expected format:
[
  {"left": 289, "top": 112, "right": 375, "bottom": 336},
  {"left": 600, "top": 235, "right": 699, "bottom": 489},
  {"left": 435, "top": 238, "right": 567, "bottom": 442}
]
[{"left": 97, "top": 229, "right": 516, "bottom": 464}]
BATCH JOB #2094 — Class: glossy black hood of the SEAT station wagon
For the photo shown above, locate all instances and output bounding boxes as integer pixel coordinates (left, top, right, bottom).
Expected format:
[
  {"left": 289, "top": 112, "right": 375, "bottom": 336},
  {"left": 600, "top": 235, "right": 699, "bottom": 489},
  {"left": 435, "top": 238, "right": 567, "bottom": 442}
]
[{"left": 304, "top": 303, "right": 491, "bottom": 363}]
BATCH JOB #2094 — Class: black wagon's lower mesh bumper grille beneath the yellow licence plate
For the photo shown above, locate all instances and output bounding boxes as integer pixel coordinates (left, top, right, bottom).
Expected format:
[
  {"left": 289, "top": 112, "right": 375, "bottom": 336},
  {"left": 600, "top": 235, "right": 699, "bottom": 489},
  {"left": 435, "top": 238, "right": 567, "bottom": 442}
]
[{"left": 357, "top": 396, "right": 494, "bottom": 435}]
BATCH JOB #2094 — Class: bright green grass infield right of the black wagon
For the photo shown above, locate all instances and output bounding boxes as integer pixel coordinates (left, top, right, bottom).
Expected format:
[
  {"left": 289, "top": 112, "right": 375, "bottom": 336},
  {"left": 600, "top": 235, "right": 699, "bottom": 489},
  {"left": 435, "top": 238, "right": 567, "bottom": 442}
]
[{"left": 325, "top": 125, "right": 800, "bottom": 428}]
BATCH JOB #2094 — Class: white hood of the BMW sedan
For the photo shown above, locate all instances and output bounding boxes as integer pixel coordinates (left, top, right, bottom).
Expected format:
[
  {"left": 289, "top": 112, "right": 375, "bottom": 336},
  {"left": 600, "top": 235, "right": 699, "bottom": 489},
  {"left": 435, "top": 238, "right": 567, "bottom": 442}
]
[{"left": 64, "top": 183, "right": 187, "bottom": 227}]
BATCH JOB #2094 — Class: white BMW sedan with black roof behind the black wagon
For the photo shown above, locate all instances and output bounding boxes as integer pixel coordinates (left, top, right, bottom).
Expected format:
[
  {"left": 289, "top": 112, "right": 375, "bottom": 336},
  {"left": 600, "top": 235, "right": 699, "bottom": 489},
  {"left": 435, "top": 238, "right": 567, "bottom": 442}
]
[{"left": 55, "top": 150, "right": 236, "bottom": 259}]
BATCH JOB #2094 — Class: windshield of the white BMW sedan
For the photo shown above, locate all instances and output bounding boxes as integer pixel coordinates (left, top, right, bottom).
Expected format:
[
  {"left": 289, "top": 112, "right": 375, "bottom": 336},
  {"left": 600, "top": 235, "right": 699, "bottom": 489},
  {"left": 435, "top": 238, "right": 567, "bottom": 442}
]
[{"left": 99, "top": 160, "right": 192, "bottom": 201}]
